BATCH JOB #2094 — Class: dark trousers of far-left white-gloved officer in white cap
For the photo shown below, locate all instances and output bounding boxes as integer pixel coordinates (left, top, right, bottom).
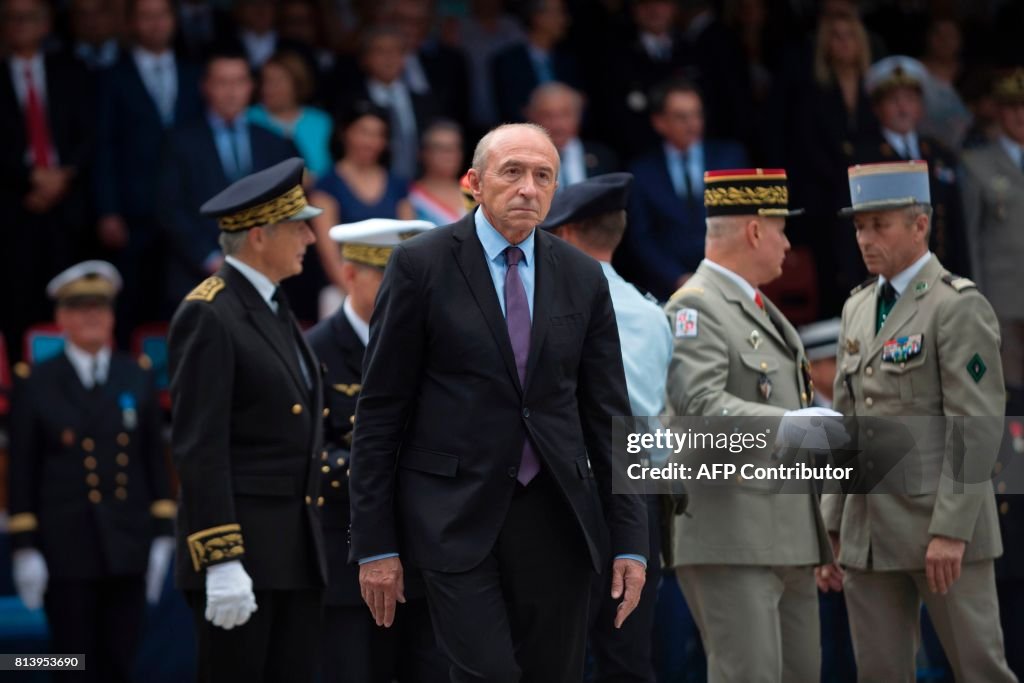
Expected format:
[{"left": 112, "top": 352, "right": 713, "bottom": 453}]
[{"left": 45, "top": 577, "right": 145, "bottom": 683}]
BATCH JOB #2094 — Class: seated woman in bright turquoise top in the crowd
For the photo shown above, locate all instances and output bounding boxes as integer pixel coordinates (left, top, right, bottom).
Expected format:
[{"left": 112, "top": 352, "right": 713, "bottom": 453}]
[{"left": 248, "top": 52, "right": 332, "bottom": 178}]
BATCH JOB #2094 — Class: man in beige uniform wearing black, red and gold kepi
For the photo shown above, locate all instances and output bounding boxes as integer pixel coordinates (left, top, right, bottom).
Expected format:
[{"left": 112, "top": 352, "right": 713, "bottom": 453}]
[{"left": 666, "top": 169, "right": 835, "bottom": 683}]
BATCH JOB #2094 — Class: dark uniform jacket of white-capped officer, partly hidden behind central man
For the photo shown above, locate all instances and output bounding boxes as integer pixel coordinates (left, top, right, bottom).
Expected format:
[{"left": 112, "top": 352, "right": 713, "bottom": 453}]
[{"left": 307, "top": 308, "right": 423, "bottom": 606}]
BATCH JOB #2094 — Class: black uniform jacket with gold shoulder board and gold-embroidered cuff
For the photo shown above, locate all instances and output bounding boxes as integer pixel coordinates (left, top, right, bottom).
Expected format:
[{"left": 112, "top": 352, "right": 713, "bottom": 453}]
[{"left": 168, "top": 265, "right": 326, "bottom": 590}]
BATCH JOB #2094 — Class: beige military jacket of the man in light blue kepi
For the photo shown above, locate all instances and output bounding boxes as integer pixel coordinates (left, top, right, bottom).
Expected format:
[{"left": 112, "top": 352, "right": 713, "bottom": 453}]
[{"left": 822, "top": 255, "right": 1006, "bottom": 570}]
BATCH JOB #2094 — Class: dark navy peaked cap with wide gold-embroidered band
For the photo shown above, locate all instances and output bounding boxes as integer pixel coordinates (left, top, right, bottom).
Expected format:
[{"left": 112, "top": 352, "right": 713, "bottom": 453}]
[{"left": 199, "top": 158, "right": 322, "bottom": 232}]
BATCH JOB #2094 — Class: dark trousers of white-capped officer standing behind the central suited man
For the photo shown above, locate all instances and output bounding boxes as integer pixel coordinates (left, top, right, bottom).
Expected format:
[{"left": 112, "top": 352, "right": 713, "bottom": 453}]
[{"left": 321, "top": 597, "right": 449, "bottom": 683}]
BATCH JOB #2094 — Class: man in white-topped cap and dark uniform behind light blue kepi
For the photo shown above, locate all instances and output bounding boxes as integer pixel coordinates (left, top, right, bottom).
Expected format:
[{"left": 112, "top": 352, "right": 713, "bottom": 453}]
[{"left": 855, "top": 55, "right": 971, "bottom": 276}]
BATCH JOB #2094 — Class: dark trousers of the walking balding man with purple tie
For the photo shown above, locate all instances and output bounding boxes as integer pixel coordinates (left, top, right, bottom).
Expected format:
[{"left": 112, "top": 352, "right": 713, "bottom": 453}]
[{"left": 423, "top": 472, "right": 593, "bottom": 683}]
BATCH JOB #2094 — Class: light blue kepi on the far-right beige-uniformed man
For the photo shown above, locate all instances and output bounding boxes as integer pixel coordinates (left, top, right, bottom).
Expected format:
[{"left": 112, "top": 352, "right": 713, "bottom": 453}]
[{"left": 839, "top": 161, "right": 932, "bottom": 216}]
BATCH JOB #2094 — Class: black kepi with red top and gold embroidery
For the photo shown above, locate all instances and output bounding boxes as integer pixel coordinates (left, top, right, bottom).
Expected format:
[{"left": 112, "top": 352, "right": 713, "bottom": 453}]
[{"left": 705, "top": 168, "right": 804, "bottom": 218}]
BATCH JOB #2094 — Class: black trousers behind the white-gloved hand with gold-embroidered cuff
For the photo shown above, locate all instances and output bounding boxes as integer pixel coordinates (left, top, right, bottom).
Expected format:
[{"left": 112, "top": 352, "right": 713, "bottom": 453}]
[{"left": 186, "top": 589, "right": 324, "bottom": 683}]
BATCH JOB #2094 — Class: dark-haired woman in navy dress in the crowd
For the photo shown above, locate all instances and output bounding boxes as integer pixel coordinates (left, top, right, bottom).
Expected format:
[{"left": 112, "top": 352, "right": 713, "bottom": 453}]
[{"left": 309, "top": 100, "right": 415, "bottom": 288}]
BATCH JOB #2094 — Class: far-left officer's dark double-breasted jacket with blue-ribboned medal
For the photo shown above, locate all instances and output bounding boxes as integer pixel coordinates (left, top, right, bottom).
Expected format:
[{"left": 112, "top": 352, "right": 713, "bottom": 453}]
[{"left": 9, "top": 352, "right": 174, "bottom": 580}]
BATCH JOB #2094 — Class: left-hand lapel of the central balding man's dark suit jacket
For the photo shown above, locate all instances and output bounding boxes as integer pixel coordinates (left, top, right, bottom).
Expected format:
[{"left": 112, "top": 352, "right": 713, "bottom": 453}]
[{"left": 453, "top": 213, "right": 524, "bottom": 394}]
